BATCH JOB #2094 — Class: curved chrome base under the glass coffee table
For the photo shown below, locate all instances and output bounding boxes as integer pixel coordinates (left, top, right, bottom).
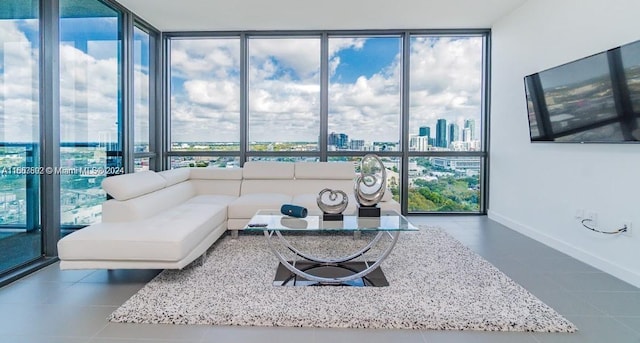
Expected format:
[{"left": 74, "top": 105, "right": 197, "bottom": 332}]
[{"left": 264, "top": 229, "right": 400, "bottom": 284}]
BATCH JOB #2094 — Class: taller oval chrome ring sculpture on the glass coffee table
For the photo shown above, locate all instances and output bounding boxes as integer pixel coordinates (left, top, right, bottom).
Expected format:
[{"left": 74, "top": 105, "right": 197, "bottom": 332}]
[{"left": 354, "top": 154, "right": 387, "bottom": 206}]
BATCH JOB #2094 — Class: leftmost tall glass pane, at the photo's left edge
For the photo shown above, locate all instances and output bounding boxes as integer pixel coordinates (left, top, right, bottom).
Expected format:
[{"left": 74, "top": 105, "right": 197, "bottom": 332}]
[{"left": 0, "top": 0, "right": 42, "bottom": 274}]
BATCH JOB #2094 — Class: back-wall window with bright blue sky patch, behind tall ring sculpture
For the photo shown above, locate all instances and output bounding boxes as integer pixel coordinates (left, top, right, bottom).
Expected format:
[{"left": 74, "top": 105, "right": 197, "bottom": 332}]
[{"left": 327, "top": 35, "right": 402, "bottom": 201}]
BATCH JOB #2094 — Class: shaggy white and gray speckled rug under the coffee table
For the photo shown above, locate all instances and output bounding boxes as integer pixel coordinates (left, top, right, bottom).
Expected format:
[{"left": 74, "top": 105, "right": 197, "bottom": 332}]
[{"left": 109, "top": 228, "right": 576, "bottom": 332}]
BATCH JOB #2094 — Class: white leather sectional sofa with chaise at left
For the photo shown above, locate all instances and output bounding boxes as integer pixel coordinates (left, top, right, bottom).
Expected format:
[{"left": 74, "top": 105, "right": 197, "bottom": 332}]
[{"left": 58, "top": 162, "right": 400, "bottom": 269}]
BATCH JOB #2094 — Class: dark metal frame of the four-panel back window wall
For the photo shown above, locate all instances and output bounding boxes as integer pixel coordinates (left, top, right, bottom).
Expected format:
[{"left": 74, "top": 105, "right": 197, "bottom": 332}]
[{"left": 163, "top": 29, "right": 491, "bottom": 215}]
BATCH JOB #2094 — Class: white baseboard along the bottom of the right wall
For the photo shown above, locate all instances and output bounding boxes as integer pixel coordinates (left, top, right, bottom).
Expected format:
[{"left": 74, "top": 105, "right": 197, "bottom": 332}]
[{"left": 488, "top": 210, "right": 640, "bottom": 287}]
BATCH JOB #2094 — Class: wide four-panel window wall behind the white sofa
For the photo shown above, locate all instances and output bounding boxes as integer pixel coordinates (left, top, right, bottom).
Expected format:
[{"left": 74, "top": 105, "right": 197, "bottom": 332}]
[{"left": 166, "top": 30, "right": 488, "bottom": 213}]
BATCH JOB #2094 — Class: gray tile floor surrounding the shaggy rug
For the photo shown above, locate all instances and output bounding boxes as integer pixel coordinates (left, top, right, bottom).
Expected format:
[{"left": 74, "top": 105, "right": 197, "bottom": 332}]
[{"left": 0, "top": 216, "right": 640, "bottom": 343}]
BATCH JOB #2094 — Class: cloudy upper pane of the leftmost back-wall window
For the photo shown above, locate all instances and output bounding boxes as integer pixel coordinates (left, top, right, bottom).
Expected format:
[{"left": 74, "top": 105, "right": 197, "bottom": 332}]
[{"left": 171, "top": 38, "right": 240, "bottom": 142}]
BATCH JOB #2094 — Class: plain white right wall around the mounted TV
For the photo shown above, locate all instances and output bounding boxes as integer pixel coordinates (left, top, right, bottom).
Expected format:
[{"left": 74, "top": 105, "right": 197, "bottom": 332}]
[{"left": 489, "top": 0, "right": 640, "bottom": 286}]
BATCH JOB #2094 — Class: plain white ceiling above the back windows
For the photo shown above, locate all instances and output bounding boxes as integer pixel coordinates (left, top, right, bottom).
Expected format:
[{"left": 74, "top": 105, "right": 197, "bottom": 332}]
[{"left": 117, "top": 0, "right": 526, "bottom": 31}]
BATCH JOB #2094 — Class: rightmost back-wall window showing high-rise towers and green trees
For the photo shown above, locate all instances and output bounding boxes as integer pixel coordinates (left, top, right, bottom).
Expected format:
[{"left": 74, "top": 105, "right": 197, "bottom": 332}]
[{"left": 408, "top": 35, "right": 485, "bottom": 212}]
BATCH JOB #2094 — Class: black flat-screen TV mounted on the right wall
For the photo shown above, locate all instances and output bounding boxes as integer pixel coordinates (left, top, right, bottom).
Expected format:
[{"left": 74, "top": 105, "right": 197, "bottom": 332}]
[{"left": 524, "top": 41, "right": 640, "bottom": 143}]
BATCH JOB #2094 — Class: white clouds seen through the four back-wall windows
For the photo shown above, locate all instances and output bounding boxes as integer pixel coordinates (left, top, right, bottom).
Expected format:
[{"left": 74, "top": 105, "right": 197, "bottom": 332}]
[{"left": 166, "top": 37, "right": 482, "bottom": 142}]
